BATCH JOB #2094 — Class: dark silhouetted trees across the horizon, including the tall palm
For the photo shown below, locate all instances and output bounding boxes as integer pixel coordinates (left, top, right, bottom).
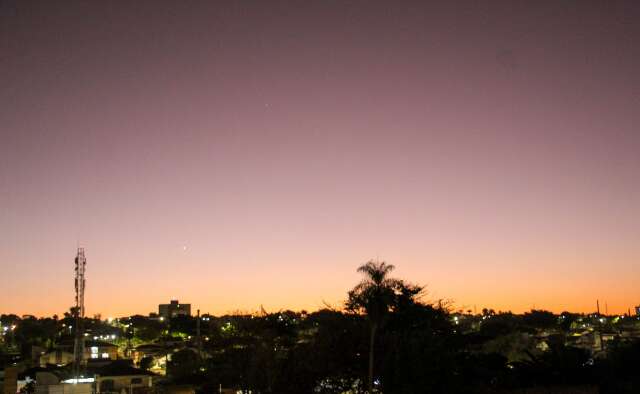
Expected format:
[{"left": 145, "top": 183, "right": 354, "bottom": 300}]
[{"left": 0, "top": 263, "right": 640, "bottom": 393}]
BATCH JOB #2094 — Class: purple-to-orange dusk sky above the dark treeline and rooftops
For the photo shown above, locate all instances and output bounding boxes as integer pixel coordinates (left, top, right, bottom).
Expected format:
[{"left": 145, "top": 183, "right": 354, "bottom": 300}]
[{"left": 0, "top": 0, "right": 640, "bottom": 317}]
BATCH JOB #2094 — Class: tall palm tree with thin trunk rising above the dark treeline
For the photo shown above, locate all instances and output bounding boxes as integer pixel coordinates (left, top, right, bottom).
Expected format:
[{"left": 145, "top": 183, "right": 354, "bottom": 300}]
[{"left": 346, "top": 261, "right": 402, "bottom": 394}]
